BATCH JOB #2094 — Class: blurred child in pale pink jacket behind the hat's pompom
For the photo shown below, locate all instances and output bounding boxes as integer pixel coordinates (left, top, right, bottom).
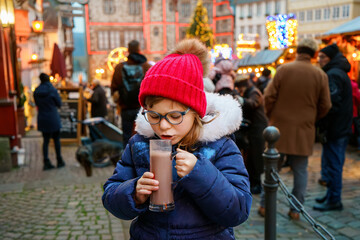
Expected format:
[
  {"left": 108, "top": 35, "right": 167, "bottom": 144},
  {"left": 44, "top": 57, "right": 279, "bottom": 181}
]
[{"left": 208, "top": 58, "right": 235, "bottom": 94}]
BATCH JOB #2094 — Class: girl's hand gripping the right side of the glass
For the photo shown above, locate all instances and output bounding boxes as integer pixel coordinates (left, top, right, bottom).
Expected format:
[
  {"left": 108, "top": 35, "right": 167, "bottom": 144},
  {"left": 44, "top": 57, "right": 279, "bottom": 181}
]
[{"left": 175, "top": 148, "right": 197, "bottom": 177}]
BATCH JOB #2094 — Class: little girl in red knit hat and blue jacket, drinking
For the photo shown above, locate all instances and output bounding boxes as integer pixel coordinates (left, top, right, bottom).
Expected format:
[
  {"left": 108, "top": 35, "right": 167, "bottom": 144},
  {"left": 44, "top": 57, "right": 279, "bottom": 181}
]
[{"left": 102, "top": 39, "right": 252, "bottom": 240}]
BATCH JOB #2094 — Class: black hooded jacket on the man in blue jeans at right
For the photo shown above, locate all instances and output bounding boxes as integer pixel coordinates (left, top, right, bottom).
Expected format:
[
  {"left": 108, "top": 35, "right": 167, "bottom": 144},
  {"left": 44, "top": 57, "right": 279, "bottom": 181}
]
[{"left": 319, "top": 52, "right": 353, "bottom": 140}]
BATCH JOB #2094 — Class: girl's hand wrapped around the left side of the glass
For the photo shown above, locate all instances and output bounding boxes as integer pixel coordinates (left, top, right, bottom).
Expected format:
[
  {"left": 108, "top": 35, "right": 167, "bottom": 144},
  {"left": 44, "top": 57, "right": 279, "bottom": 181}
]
[{"left": 134, "top": 172, "right": 159, "bottom": 205}]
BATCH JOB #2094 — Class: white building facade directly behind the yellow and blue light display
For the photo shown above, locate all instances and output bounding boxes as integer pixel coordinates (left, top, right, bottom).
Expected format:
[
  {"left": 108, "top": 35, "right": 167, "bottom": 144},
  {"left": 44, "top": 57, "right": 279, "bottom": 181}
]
[{"left": 234, "top": 0, "right": 288, "bottom": 49}]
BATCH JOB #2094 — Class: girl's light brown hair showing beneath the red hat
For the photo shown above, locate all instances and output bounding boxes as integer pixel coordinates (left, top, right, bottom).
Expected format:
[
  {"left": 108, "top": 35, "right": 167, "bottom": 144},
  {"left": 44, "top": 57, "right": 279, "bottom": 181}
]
[{"left": 145, "top": 96, "right": 203, "bottom": 151}]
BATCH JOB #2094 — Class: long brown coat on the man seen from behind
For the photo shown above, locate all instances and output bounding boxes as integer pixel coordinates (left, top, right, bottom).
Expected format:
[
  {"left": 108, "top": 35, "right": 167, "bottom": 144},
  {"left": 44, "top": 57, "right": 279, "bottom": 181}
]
[{"left": 264, "top": 54, "right": 331, "bottom": 156}]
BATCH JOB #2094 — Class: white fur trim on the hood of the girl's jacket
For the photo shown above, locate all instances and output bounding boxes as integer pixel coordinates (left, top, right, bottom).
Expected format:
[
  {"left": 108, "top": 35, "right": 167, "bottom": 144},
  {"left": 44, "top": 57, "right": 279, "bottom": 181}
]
[{"left": 135, "top": 93, "right": 242, "bottom": 142}]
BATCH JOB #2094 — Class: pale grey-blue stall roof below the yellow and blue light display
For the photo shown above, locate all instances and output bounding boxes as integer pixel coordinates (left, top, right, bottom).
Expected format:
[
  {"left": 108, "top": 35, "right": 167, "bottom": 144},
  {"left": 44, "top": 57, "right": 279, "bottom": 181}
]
[{"left": 234, "top": 49, "right": 284, "bottom": 68}]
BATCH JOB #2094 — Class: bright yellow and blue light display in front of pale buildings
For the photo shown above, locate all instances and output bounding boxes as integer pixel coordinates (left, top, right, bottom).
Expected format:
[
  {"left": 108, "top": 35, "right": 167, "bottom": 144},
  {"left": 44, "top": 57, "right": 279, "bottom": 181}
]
[{"left": 266, "top": 13, "right": 297, "bottom": 49}]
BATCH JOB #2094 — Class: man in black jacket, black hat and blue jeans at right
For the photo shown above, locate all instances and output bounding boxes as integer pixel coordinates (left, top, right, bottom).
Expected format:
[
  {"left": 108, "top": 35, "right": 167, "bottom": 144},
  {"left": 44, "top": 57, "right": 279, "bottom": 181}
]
[{"left": 314, "top": 44, "right": 352, "bottom": 211}]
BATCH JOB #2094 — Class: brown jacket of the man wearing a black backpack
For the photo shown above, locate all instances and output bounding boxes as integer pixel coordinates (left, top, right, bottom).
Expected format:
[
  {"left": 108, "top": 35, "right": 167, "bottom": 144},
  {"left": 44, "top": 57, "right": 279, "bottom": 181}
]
[{"left": 111, "top": 53, "right": 151, "bottom": 110}]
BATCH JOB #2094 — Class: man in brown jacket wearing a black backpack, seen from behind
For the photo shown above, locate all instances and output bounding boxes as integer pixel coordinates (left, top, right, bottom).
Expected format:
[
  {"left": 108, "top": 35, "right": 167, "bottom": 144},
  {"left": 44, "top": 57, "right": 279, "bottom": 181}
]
[{"left": 111, "top": 40, "right": 151, "bottom": 146}]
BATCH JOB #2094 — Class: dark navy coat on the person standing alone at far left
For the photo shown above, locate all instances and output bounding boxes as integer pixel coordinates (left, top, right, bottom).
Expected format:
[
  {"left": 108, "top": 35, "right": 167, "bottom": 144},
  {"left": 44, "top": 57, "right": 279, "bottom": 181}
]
[{"left": 34, "top": 82, "right": 61, "bottom": 133}]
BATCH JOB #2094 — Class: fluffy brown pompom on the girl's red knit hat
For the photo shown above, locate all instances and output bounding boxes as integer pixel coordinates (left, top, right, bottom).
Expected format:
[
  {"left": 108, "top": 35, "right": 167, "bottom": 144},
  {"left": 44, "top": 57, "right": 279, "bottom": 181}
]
[{"left": 170, "top": 38, "right": 211, "bottom": 76}]
